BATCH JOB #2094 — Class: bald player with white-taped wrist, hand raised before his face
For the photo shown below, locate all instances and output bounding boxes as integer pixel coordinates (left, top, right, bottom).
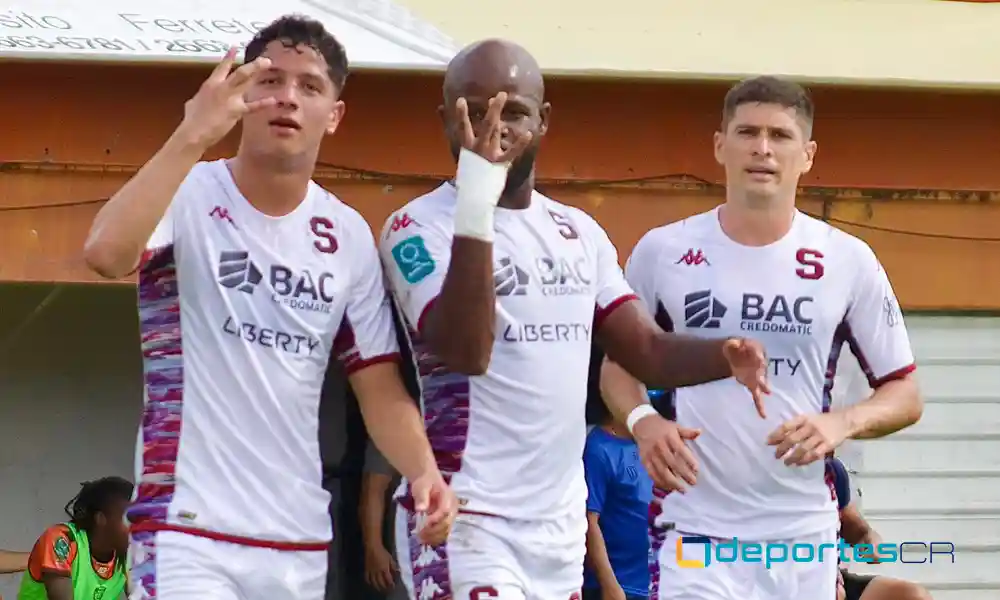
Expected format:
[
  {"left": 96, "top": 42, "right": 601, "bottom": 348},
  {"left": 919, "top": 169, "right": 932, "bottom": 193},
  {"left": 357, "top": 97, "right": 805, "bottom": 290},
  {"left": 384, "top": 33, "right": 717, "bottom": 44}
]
[{"left": 380, "top": 40, "right": 767, "bottom": 600}]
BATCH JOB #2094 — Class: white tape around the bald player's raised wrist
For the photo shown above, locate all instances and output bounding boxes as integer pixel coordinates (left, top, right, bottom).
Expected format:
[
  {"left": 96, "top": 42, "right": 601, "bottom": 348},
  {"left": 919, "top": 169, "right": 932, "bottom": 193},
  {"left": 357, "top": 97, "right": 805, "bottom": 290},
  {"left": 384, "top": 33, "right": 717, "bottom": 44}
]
[{"left": 455, "top": 148, "right": 509, "bottom": 242}]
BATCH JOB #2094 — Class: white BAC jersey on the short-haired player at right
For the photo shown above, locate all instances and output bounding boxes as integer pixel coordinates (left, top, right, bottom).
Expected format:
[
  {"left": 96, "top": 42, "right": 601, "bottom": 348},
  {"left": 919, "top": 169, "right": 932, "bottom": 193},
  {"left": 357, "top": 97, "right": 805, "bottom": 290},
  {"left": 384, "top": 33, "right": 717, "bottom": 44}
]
[{"left": 625, "top": 209, "right": 914, "bottom": 540}]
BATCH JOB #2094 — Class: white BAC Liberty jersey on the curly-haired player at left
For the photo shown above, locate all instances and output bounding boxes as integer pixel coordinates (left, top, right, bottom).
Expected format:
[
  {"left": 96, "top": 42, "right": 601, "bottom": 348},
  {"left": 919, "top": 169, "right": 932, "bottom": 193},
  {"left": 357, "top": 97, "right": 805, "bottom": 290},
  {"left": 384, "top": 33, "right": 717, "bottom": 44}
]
[{"left": 129, "top": 160, "right": 398, "bottom": 542}]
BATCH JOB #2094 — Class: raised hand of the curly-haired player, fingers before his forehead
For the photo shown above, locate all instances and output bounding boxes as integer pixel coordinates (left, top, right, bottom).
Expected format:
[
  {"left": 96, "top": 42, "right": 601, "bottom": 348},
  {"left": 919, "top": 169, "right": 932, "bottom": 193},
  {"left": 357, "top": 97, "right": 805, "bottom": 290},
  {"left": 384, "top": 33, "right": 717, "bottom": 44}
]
[{"left": 179, "top": 48, "right": 277, "bottom": 149}]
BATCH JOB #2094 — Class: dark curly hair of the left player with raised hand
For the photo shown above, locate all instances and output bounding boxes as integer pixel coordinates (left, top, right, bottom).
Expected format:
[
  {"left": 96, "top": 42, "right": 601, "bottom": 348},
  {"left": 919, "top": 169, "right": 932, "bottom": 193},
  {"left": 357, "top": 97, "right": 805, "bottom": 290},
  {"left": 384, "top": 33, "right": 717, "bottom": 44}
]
[{"left": 243, "top": 15, "right": 349, "bottom": 93}]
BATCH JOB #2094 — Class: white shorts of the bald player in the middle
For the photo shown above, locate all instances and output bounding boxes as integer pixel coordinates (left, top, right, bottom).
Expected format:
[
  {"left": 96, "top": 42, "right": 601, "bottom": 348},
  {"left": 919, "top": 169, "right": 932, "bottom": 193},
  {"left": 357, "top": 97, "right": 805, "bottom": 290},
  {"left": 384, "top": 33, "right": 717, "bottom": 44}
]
[{"left": 396, "top": 507, "right": 587, "bottom": 600}]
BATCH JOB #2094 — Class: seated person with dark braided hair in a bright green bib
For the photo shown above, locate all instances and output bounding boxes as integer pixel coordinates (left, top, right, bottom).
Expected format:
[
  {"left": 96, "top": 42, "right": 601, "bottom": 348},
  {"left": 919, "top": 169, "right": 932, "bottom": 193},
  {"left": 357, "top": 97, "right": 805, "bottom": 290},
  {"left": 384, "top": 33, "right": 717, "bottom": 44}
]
[{"left": 17, "top": 477, "right": 132, "bottom": 600}]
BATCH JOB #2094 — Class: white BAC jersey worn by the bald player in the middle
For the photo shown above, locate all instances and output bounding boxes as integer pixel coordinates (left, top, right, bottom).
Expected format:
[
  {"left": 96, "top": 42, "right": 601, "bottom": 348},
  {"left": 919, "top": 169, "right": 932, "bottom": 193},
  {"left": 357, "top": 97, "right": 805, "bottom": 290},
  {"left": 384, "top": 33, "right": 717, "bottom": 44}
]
[{"left": 380, "top": 184, "right": 634, "bottom": 519}]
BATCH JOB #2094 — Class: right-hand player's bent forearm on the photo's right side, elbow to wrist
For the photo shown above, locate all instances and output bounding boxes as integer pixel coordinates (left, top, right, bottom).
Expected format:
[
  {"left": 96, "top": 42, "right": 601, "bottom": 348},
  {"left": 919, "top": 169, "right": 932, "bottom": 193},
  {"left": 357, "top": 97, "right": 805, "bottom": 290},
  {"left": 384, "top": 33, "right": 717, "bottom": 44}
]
[{"left": 841, "top": 376, "right": 924, "bottom": 440}]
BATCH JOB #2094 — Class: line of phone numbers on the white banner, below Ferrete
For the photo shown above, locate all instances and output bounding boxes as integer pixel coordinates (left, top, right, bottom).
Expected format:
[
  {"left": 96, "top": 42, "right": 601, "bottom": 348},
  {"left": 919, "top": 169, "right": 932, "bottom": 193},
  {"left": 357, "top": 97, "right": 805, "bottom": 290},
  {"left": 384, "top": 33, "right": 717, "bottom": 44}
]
[{"left": 0, "top": 35, "right": 246, "bottom": 56}]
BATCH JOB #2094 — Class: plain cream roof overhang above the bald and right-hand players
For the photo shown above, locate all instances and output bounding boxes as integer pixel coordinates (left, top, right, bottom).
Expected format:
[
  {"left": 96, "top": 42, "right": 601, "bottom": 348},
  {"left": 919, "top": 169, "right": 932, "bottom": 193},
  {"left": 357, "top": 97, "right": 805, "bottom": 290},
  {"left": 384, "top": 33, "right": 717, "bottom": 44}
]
[{"left": 399, "top": 0, "right": 1000, "bottom": 89}]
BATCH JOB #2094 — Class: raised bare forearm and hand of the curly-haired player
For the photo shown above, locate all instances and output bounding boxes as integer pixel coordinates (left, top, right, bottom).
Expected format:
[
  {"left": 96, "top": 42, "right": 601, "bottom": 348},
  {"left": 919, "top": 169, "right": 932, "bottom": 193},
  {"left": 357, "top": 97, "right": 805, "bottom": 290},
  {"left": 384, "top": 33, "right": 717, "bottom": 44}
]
[{"left": 83, "top": 50, "right": 275, "bottom": 279}]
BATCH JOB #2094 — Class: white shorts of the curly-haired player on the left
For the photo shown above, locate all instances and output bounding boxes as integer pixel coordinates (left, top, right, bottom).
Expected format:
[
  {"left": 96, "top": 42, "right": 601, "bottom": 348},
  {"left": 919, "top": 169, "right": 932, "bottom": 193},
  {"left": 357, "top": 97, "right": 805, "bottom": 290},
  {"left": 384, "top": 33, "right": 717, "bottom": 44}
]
[{"left": 129, "top": 531, "right": 327, "bottom": 600}]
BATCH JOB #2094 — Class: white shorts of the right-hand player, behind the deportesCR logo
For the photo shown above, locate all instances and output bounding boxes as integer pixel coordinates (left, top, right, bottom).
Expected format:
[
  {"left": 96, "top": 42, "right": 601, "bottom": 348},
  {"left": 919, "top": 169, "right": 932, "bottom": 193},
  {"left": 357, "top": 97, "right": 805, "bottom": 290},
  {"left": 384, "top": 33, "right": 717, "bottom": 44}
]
[{"left": 649, "top": 530, "right": 838, "bottom": 600}]
